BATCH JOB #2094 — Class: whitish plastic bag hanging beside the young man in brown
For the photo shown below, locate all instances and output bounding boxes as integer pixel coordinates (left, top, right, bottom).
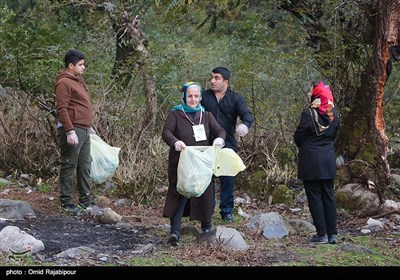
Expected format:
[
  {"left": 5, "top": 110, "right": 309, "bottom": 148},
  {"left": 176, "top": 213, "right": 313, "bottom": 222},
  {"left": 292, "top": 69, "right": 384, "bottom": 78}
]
[{"left": 90, "top": 134, "right": 121, "bottom": 184}]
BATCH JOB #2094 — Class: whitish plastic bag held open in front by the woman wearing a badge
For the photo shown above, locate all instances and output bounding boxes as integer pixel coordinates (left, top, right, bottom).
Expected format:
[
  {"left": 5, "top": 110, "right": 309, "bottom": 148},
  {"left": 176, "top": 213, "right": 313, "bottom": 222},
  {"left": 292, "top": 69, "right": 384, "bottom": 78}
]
[{"left": 176, "top": 146, "right": 215, "bottom": 198}]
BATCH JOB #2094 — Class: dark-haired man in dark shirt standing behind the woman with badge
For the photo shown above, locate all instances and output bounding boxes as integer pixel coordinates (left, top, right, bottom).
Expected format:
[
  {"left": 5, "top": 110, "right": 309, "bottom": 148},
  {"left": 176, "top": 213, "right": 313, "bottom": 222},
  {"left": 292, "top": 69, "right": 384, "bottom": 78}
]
[{"left": 201, "top": 67, "right": 254, "bottom": 222}]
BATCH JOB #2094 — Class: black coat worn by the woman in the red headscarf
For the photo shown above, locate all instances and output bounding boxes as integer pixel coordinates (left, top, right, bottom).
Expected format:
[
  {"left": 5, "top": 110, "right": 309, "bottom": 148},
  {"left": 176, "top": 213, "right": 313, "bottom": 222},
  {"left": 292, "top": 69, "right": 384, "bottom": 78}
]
[{"left": 294, "top": 108, "right": 339, "bottom": 180}]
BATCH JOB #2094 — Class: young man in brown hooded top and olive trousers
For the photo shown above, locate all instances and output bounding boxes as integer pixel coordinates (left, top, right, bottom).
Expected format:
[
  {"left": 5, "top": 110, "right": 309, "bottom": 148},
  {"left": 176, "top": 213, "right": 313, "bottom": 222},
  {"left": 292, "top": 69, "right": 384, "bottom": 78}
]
[{"left": 55, "top": 49, "right": 95, "bottom": 215}]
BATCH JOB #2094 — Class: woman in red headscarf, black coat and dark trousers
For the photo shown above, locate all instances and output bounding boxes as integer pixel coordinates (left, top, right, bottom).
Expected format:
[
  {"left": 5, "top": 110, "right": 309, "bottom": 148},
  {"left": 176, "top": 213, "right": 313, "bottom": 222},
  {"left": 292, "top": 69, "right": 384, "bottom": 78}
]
[{"left": 294, "top": 81, "right": 339, "bottom": 244}]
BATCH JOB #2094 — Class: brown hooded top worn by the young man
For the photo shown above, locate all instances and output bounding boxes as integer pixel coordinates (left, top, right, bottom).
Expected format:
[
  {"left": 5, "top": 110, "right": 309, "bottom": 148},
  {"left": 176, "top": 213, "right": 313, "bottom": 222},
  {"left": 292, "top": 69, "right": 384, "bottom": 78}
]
[{"left": 55, "top": 71, "right": 93, "bottom": 131}]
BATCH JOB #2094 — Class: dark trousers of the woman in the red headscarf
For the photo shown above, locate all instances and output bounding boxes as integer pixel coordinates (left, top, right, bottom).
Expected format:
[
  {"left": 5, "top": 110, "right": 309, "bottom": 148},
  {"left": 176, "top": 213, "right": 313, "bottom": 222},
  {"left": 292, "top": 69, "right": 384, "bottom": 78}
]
[{"left": 303, "top": 180, "right": 337, "bottom": 235}]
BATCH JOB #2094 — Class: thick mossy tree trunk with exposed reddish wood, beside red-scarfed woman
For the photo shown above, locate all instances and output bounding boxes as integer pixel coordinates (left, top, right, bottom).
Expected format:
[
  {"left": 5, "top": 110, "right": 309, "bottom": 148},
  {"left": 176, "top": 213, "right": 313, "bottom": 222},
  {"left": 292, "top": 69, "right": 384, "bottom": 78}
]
[{"left": 339, "top": 0, "right": 400, "bottom": 199}]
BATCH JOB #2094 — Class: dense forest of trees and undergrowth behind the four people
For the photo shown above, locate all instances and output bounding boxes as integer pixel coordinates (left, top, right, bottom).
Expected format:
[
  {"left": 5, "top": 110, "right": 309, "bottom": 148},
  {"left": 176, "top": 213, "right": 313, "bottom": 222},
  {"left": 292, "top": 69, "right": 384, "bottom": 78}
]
[{"left": 0, "top": 0, "right": 400, "bottom": 209}]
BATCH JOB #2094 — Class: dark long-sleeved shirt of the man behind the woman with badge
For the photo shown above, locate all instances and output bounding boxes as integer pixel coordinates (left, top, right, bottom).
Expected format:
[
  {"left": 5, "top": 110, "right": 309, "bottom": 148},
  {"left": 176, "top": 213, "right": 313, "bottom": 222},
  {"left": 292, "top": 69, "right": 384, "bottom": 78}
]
[{"left": 201, "top": 88, "right": 254, "bottom": 151}]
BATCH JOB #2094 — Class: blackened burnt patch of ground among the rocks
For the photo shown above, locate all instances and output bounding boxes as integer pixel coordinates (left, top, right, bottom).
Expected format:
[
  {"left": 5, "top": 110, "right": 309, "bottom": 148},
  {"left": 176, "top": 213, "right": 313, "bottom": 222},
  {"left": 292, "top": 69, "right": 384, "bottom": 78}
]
[{"left": 0, "top": 213, "right": 159, "bottom": 260}]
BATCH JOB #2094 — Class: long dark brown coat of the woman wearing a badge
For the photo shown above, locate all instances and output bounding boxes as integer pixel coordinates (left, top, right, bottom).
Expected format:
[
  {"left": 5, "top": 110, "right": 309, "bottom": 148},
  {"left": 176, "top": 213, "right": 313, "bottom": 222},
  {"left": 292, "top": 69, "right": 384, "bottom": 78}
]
[{"left": 162, "top": 111, "right": 226, "bottom": 222}]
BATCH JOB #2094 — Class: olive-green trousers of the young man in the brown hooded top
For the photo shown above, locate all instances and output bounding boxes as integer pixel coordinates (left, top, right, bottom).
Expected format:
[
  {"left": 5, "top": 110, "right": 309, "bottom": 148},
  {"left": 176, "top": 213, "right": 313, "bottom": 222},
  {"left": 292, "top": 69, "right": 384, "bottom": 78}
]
[{"left": 57, "top": 127, "right": 92, "bottom": 205}]
